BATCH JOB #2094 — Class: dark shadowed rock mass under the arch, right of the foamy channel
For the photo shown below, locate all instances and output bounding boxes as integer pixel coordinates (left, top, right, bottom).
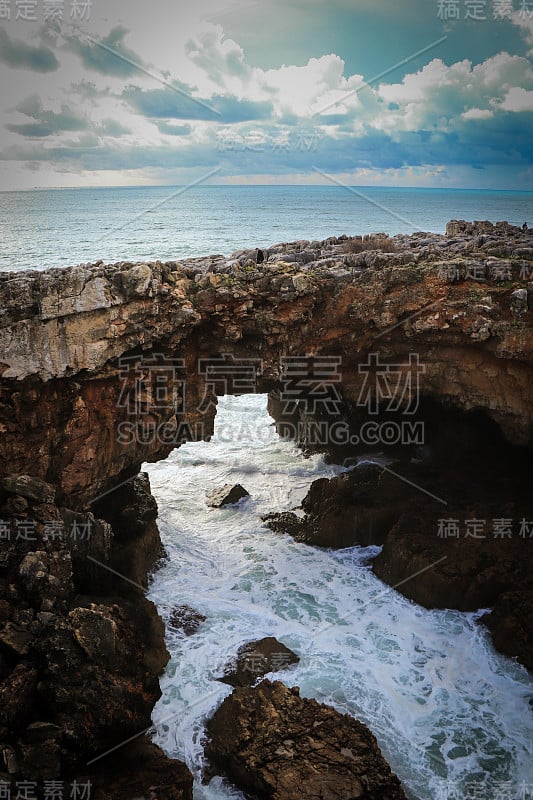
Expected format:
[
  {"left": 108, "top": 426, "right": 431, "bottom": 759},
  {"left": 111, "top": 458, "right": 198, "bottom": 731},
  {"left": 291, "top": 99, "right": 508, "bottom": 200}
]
[{"left": 265, "top": 409, "right": 533, "bottom": 668}]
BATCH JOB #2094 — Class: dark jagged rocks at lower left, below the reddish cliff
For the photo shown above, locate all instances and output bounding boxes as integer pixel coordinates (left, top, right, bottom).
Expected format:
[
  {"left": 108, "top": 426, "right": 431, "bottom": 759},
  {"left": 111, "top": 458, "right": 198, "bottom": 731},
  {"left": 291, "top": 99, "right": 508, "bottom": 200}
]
[{"left": 0, "top": 475, "right": 192, "bottom": 800}]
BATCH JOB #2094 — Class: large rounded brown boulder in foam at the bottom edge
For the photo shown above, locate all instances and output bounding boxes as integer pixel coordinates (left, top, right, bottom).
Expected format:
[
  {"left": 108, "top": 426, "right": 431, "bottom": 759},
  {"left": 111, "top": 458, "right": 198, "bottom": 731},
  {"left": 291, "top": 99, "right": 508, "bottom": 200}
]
[{"left": 205, "top": 680, "right": 405, "bottom": 800}]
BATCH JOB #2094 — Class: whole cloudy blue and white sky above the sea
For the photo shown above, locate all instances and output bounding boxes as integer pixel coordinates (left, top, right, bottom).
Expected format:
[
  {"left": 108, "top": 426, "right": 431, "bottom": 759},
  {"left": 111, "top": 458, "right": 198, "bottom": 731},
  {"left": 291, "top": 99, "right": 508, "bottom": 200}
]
[{"left": 0, "top": 0, "right": 533, "bottom": 189}]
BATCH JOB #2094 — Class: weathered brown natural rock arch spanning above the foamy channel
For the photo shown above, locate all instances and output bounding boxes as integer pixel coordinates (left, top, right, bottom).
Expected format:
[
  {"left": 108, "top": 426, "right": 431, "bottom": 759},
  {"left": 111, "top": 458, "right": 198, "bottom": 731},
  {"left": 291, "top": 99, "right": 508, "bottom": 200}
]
[{"left": 0, "top": 221, "right": 533, "bottom": 508}]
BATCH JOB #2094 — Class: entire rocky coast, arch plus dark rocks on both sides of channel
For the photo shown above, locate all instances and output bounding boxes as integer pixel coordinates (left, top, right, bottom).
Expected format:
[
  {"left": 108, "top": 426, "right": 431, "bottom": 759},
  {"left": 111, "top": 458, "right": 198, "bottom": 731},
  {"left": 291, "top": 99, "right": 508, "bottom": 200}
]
[{"left": 0, "top": 221, "right": 533, "bottom": 800}]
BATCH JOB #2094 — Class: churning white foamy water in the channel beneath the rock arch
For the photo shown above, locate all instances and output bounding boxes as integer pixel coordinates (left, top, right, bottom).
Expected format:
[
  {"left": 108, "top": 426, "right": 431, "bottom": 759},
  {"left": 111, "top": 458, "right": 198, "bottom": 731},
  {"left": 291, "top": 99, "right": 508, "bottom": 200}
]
[{"left": 145, "top": 395, "right": 533, "bottom": 800}]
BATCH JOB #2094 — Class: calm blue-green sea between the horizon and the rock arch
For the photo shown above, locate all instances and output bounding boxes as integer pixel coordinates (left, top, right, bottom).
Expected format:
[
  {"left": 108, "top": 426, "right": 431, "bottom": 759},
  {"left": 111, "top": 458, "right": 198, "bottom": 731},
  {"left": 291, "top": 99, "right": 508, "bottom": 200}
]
[{"left": 0, "top": 185, "right": 533, "bottom": 271}]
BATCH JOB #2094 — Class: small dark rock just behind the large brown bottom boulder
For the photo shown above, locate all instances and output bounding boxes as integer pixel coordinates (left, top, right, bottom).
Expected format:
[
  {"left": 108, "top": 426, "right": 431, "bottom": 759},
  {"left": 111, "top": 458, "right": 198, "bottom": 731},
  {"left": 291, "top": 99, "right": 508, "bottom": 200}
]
[{"left": 218, "top": 636, "right": 300, "bottom": 686}]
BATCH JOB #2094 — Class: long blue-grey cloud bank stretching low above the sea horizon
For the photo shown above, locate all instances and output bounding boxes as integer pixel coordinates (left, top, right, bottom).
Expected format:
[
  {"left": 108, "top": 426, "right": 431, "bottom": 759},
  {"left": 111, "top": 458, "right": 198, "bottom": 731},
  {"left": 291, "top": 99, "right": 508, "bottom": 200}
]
[{"left": 0, "top": 112, "right": 533, "bottom": 175}]
